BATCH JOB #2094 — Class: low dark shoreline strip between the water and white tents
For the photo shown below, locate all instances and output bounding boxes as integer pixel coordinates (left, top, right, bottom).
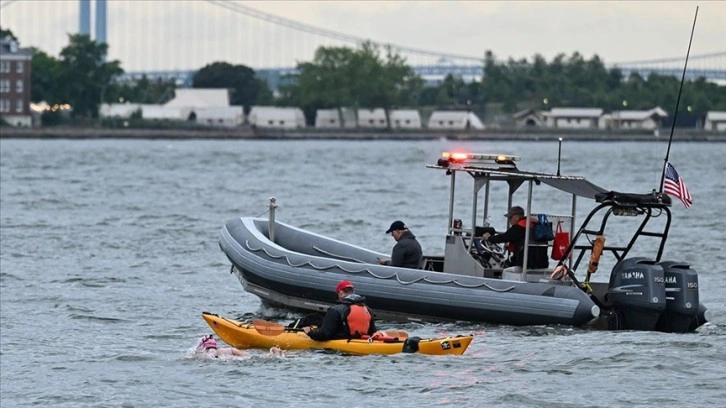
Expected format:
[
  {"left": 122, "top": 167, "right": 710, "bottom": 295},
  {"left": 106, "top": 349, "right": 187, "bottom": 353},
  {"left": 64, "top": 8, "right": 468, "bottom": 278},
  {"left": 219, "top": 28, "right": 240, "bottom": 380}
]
[{"left": 0, "top": 127, "right": 726, "bottom": 142}]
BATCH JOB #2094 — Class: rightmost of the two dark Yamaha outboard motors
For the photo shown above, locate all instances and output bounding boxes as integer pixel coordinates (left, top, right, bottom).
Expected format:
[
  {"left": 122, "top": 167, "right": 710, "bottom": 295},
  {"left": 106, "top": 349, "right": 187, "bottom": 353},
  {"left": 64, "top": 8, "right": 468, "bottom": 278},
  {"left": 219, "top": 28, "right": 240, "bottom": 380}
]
[{"left": 657, "top": 261, "right": 699, "bottom": 333}]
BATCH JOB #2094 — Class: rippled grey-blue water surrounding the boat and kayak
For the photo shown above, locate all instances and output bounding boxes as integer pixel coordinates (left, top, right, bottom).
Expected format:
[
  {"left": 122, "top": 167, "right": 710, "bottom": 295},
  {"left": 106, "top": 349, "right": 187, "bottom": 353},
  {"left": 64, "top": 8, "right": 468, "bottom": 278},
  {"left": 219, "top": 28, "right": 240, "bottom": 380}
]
[{"left": 0, "top": 140, "right": 726, "bottom": 407}]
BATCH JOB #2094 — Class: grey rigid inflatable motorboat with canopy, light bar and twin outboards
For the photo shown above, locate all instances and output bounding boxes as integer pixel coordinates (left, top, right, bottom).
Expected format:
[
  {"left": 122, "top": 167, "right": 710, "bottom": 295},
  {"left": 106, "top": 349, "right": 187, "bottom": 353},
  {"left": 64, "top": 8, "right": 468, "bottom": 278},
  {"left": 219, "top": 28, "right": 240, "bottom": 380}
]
[{"left": 219, "top": 153, "right": 706, "bottom": 332}]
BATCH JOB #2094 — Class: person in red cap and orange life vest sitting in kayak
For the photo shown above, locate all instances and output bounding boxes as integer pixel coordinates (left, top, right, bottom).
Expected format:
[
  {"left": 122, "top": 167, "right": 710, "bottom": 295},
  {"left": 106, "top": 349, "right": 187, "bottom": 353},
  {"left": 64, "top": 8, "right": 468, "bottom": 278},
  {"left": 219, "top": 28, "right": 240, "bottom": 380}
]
[{"left": 303, "top": 280, "right": 376, "bottom": 341}]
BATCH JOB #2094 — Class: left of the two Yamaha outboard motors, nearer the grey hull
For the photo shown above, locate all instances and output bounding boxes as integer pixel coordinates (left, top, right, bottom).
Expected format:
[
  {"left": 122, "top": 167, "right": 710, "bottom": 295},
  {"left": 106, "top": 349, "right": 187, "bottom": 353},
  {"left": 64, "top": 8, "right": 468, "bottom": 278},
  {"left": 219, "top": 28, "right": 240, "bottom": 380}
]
[{"left": 608, "top": 257, "right": 666, "bottom": 330}]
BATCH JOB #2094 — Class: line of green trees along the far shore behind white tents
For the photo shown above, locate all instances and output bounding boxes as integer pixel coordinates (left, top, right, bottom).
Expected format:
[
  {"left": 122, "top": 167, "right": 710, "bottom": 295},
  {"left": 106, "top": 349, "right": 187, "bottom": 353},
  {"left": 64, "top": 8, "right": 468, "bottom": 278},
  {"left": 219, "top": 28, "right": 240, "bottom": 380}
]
[{"left": 0, "top": 29, "right": 726, "bottom": 123}]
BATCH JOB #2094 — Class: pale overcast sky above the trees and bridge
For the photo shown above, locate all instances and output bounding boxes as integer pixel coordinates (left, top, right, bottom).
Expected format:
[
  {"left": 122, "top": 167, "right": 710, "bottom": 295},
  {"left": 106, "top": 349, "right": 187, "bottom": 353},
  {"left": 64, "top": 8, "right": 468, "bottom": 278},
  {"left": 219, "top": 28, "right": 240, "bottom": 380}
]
[{"left": 0, "top": 0, "right": 726, "bottom": 71}]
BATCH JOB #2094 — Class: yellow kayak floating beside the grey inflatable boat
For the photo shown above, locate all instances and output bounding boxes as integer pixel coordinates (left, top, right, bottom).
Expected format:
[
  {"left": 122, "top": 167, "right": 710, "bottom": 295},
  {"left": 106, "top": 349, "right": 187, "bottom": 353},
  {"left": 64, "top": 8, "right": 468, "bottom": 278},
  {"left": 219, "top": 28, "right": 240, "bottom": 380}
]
[{"left": 202, "top": 312, "right": 474, "bottom": 355}]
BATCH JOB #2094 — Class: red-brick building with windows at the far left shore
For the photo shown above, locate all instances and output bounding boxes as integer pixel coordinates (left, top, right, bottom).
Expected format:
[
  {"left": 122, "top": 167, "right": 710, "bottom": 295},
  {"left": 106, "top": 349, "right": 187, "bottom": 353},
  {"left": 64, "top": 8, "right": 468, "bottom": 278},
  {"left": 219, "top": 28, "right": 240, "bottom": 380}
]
[{"left": 0, "top": 37, "right": 33, "bottom": 127}]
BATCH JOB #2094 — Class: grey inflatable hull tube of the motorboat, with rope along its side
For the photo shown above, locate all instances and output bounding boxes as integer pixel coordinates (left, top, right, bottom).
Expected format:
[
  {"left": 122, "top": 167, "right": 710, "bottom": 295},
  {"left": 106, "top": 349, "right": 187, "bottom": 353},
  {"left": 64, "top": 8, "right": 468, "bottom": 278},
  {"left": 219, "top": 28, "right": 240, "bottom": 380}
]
[{"left": 219, "top": 218, "right": 599, "bottom": 326}]
